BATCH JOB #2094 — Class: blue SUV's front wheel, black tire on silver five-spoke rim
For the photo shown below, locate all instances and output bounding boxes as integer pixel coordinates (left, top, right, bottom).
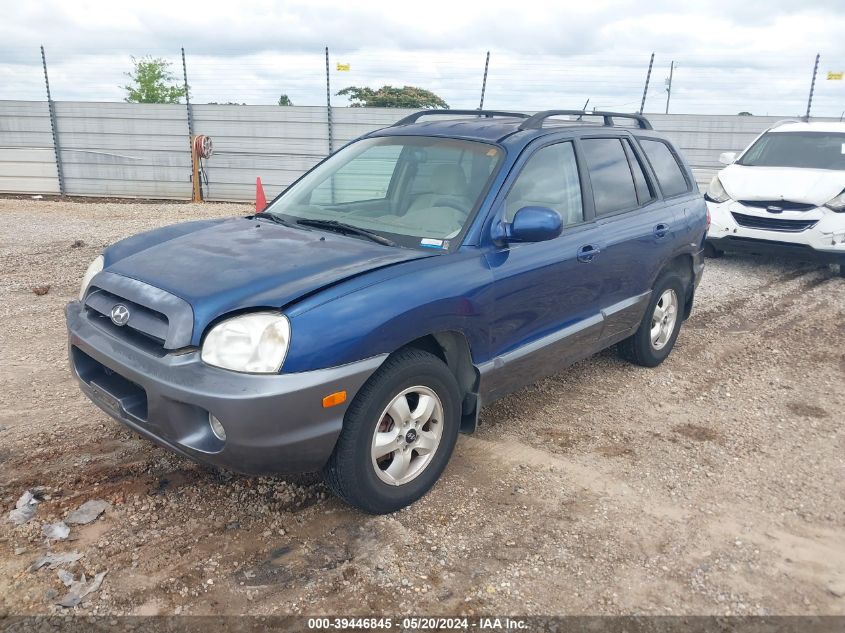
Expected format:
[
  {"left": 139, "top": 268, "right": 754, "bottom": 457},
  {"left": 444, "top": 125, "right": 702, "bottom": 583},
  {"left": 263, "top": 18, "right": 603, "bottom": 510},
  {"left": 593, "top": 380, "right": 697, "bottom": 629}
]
[{"left": 323, "top": 348, "right": 461, "bottom": 514}]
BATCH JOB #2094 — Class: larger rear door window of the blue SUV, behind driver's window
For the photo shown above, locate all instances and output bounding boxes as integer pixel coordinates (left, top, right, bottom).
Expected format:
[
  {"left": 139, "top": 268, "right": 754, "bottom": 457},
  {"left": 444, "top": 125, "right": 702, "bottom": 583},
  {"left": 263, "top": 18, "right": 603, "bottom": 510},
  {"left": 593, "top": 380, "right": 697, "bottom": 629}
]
[{"left": 582, "top": 138, "right": 639, "bottom": 217}]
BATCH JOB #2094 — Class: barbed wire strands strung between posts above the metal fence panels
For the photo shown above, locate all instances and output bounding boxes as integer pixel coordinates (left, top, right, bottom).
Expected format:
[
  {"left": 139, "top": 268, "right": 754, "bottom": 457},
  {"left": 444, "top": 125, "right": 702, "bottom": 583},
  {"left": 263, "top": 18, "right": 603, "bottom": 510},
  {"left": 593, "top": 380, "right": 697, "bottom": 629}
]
[{"left": 0, "top": 45, "right": 845, "bottom": 117}]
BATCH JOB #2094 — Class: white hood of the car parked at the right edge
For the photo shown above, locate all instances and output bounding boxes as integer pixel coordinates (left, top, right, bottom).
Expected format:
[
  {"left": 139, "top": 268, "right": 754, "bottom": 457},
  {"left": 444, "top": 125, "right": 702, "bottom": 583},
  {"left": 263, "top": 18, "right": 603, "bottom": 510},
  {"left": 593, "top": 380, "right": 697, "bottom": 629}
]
[{"left": 719, "top": 164, "right": 845, "bottom": 206}]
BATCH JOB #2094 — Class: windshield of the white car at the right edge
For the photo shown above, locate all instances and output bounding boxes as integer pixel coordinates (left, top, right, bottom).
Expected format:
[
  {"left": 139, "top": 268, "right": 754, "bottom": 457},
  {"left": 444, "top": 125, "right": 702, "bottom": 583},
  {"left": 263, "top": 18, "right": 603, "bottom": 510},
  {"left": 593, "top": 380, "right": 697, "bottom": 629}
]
[{"left": 737, "top": 132, "right": 845, "bottom": 170}]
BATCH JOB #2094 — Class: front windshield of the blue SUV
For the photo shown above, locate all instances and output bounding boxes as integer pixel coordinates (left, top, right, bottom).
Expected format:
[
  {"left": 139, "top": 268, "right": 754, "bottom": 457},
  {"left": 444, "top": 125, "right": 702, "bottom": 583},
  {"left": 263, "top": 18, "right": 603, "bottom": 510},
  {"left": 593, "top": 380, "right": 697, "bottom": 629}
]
[{"left": 267, "top": 136, "right": 502, "bottom": 250}]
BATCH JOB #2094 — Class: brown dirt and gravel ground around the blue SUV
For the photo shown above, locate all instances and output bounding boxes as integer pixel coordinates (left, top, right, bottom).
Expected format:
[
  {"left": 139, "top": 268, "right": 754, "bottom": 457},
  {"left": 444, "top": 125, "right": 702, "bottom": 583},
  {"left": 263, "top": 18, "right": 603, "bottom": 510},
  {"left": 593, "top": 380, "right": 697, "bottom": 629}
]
[{"left": 0, "top": 199, "right": 845, "bottom": 615}]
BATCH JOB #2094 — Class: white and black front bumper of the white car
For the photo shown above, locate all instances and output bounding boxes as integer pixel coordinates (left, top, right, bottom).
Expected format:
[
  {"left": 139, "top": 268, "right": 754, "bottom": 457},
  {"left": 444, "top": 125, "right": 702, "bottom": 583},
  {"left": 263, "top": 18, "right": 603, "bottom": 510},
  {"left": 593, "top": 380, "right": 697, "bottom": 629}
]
[{"left": 707, "top": 200, "right": 845, "bottom": 263}]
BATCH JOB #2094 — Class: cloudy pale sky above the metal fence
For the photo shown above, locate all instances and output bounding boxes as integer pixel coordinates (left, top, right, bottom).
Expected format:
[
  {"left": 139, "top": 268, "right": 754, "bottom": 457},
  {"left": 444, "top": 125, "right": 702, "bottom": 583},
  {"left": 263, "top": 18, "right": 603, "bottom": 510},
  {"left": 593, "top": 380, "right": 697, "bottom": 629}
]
[{"left": 0, "top": 0, "right": 845, "bottom": 117}]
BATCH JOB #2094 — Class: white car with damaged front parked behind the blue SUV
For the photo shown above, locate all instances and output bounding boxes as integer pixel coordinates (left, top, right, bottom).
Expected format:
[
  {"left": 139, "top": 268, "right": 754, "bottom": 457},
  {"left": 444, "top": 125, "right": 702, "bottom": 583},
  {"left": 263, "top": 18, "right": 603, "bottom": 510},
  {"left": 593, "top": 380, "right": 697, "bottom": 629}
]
[{"left": 704, "top": 122, "right": 845, "bottom": 276}]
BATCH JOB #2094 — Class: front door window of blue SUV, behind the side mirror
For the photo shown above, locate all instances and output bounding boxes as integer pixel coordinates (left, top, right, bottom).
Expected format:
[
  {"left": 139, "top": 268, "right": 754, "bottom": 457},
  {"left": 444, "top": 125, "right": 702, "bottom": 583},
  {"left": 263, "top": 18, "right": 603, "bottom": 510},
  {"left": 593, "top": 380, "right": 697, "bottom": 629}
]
[{"left": 505, "top": 142, "right": 584, "bottom": 226}]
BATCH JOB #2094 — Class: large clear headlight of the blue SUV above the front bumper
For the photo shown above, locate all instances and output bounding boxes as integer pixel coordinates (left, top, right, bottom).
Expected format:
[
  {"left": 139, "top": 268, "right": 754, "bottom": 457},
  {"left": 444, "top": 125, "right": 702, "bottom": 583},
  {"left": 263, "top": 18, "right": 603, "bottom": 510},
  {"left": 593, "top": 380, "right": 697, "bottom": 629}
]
[{"left": 201, "top": 312, "right": 290, "bottom": 374}]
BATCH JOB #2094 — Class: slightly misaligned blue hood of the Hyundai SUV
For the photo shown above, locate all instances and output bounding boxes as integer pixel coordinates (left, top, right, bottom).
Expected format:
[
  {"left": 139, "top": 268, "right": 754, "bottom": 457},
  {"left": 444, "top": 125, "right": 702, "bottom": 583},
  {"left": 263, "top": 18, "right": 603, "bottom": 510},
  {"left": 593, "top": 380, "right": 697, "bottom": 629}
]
[{"left": 105, "top": 218, "right": 431, "bottom": 332}]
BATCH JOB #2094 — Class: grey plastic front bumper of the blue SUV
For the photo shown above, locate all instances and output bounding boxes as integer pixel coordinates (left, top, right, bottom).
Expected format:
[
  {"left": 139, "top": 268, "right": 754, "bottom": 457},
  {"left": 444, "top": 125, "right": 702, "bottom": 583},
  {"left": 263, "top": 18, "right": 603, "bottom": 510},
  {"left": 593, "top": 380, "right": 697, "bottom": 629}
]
[{"left": 65, "top": 301, "right": 385, "bottom": 474}]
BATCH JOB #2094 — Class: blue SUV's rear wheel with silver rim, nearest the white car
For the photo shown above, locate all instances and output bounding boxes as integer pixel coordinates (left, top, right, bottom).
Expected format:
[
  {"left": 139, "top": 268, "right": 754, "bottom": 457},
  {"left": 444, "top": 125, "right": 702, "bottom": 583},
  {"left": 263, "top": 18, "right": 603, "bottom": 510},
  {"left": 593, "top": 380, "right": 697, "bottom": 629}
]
[{"left": 619, "top": 273, "right": 687, "bottom": 367}]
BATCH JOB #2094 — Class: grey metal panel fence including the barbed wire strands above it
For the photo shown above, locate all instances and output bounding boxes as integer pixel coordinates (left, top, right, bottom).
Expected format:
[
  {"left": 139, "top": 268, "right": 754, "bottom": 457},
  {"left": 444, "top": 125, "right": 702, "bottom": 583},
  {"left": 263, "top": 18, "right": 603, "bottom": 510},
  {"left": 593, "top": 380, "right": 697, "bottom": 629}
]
[{"left": 0, "top": 46, "right": 845, "bottom": 200}]
